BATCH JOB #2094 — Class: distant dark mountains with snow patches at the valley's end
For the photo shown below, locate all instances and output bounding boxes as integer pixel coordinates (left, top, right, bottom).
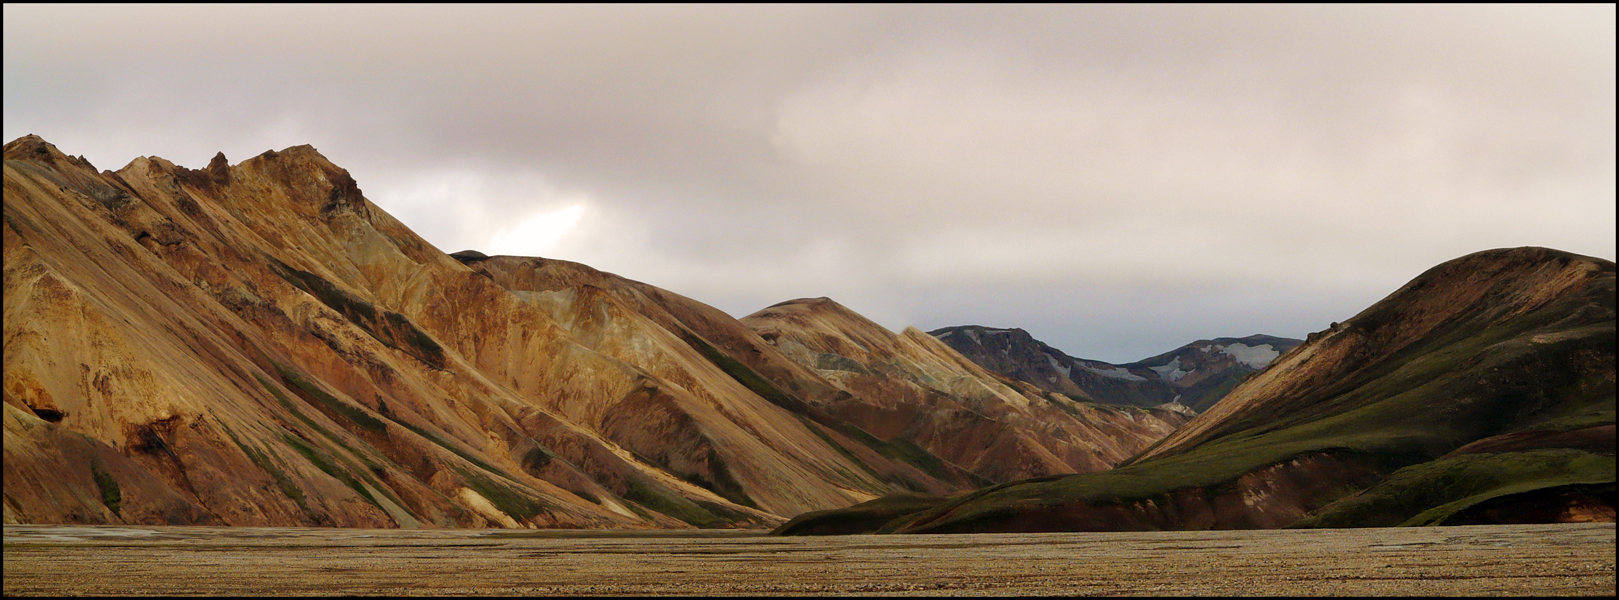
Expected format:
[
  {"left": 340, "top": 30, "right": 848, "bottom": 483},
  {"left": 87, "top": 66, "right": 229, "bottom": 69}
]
[{"left": 928, "top": 325, "right": 1302, "bottom": 411}]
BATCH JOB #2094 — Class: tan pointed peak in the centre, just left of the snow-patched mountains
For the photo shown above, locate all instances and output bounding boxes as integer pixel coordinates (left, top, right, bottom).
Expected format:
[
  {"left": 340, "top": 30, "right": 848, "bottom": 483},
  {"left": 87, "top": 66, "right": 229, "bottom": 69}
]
[{"left": 742, "top": 298, "right": 1187, "bottom": 482}]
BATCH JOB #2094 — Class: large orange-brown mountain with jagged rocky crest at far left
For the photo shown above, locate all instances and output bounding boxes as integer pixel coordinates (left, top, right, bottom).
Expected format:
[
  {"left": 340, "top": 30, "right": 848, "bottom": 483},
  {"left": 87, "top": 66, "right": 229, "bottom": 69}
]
[{"left": 5, "top": 137, "right": 767, "bottom": 527}]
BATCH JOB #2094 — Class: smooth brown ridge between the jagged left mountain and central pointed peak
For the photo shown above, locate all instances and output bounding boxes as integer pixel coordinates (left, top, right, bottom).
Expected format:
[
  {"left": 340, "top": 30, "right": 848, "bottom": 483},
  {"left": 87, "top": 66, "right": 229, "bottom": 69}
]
[{"left": 458, "top": 254, "right": 971, "bottom": 503}]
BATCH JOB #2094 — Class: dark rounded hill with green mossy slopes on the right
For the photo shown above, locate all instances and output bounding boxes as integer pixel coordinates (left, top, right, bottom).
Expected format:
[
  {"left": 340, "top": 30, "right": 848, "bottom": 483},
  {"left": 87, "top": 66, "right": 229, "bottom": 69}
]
[{"left": 777, "top": 247, "right": 1616, "bottom": 534}]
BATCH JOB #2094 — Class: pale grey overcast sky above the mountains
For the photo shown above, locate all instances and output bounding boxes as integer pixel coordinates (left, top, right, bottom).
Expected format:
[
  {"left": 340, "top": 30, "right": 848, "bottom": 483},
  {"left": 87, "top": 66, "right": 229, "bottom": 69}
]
[{"left": 5, "top": 5, "right": 1616, "bottom": 362}]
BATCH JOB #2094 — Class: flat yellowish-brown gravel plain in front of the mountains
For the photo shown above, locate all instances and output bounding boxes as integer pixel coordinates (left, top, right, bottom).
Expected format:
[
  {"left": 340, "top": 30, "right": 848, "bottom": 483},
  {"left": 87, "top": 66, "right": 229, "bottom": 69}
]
[{"left": 3, "top": 522, "right": 1614, "bottom": 595}]
